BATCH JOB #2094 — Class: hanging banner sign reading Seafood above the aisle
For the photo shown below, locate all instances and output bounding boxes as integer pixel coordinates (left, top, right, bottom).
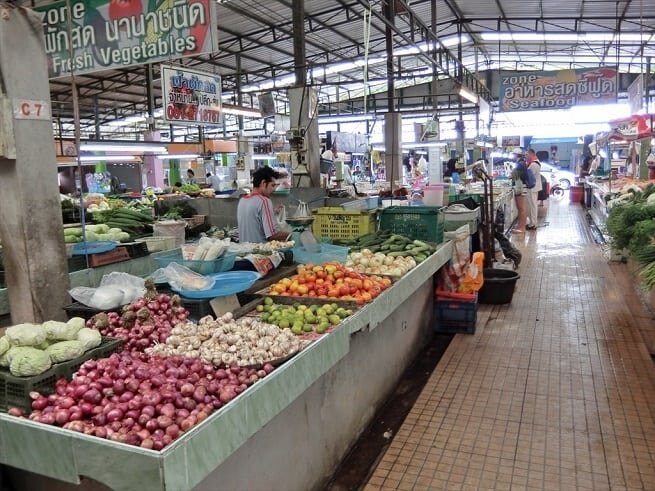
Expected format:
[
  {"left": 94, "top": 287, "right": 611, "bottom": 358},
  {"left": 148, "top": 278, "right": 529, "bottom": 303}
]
[{"left": 499, "top": 67, "right": 618, "bottom": 111}]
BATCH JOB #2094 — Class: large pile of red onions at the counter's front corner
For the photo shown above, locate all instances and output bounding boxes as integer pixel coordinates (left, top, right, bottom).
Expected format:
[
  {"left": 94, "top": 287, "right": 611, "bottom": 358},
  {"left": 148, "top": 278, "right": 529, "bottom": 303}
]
[{"left": 9, "top": 352, "right": 273, "bottom": 450}]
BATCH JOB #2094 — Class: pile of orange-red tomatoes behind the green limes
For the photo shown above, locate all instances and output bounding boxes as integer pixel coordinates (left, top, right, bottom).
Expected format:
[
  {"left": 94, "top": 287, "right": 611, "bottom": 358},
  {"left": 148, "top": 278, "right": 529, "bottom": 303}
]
[{"left": 269, "top": 261, "right": 391, "bottom": 305}]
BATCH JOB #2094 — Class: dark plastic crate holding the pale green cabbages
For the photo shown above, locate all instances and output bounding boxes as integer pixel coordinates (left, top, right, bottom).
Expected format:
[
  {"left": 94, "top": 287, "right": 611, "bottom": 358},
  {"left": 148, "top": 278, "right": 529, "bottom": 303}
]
[{"left": 0, "top": 337, "right": 123, "bottom": 413}]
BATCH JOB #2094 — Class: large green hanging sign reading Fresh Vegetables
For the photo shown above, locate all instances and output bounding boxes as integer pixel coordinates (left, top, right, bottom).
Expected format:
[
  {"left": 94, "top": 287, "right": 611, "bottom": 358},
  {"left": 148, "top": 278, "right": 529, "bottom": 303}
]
[{"left": 35, "top": 0, "right": 218, "bottom": 78}]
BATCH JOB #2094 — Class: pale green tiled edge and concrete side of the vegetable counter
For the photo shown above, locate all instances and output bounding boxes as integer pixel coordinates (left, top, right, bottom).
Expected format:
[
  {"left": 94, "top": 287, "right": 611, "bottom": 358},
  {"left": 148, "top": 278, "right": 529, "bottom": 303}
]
[{"left": 0, "top": 242, "right": 452, "bottom": 490}]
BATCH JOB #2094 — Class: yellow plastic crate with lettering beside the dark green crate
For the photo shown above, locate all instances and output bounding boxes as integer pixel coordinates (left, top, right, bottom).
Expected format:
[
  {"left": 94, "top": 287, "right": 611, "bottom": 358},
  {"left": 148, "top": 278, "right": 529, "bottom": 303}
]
[{"left": 312, "top": 206, "right": 377, "bottom": 240}]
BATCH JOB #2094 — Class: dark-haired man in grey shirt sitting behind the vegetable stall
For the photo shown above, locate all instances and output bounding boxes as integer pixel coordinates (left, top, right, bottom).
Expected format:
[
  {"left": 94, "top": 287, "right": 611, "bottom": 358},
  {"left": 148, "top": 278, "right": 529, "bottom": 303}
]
[{"left": 237, "top": 166, "right": 289, "bottom": 243}]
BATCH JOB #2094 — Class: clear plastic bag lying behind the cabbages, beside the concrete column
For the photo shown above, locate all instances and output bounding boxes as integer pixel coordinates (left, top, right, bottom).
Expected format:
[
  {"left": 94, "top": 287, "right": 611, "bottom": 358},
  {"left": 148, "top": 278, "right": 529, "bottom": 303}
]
[{"left": 68, "top": 271, "right": 145, "bottom": 310}]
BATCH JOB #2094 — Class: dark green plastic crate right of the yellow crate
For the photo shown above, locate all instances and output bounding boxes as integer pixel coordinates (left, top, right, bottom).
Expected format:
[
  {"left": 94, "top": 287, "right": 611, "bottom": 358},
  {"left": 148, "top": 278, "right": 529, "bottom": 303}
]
[{"left": 380, "top": 206, "right": 444, "bottom": 244}]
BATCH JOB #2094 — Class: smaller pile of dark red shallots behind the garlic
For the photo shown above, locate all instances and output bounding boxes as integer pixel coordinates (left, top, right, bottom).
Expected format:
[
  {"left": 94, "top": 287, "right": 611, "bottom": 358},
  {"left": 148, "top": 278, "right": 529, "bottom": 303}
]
[{"left": 86, "top": 292, "right": 189, "bottom": 352}]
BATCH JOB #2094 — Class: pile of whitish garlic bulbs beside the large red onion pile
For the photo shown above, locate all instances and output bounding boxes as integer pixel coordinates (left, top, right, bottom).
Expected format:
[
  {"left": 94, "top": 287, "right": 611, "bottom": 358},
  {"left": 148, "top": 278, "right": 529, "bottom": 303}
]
[{"left": 146, "top": 313, "right": 306, "bottom": 367}]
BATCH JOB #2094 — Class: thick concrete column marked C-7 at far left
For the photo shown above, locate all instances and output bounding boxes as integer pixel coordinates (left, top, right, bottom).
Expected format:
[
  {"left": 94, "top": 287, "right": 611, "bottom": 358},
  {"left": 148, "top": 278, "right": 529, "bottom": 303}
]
[{"left": 0, "top": 4, "right": 70, "bottom": 323}]
